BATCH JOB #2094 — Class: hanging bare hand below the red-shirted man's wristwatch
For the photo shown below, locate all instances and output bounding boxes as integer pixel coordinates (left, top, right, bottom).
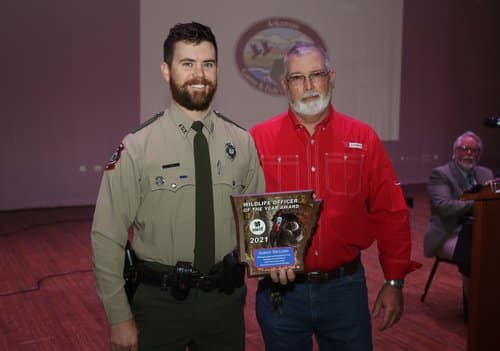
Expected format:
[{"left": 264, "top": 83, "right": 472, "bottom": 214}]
[{"left": 372, "top": 284, "right": 403, "bottom": 331}]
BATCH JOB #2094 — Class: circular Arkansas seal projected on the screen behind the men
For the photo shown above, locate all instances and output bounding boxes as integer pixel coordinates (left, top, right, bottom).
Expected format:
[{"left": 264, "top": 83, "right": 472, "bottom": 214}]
[{"left": 236, "top": 17, "right": 326, "bottom": 95}]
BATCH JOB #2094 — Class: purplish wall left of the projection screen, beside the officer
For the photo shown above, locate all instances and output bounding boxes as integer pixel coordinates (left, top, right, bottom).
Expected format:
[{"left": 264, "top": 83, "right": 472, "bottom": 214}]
[{"left": 0, "top": 0, "right": 139, "bottom": 209}]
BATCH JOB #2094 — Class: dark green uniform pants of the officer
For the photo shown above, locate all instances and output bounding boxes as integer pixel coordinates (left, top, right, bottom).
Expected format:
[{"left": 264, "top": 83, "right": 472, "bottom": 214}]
[{"left": 132, "top": 284, "right": 246, "bottom": 351}]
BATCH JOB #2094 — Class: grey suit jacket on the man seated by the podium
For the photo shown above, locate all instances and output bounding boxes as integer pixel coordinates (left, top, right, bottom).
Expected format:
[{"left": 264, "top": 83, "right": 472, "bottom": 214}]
[{"left": 424, "top": 161, "right": 494, "bottom": 257}]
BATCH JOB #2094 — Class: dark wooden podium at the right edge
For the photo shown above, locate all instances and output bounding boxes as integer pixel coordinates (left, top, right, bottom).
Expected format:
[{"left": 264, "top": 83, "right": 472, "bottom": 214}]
[{"left": 462, "top": 186, "right": 500, "bottom": 351}]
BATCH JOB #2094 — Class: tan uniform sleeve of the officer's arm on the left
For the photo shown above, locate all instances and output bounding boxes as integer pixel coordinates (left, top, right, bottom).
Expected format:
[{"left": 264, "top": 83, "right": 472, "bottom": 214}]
[{"left": 91, "top": 139, "right": 140, "bottom": 324}]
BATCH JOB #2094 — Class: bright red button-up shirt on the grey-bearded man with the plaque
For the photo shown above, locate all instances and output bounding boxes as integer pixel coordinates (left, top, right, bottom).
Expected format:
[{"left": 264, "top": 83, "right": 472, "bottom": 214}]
[{"left": 250, "top": 107, "right": 418, "bottom": 279}]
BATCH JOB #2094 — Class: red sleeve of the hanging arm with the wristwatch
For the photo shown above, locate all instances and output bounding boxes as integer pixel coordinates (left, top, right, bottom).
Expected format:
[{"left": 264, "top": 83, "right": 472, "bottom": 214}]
[{"left": 367, "top": 134, "right": 422, "bottom": 279}]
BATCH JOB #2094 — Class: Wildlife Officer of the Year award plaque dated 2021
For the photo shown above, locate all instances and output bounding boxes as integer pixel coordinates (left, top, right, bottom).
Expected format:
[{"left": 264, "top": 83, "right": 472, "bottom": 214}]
[{"left": 231, "top": 190, "right": 321, "bottom": 277}]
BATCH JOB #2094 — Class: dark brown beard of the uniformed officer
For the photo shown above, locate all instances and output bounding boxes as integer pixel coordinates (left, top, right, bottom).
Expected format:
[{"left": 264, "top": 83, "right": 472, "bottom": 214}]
[{"left": 170, "top": 78, "right": 217, "bottom": 111}]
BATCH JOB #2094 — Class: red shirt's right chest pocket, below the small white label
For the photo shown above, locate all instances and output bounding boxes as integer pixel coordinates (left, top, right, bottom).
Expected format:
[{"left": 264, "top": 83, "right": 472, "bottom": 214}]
[{"left": 324, "top": 149, "right": 366, "bottom": 196}]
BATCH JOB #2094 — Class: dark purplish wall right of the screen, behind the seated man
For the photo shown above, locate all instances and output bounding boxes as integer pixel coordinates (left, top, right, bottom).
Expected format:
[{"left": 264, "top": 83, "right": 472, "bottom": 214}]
[{"left": 386, "top": 0, "right": 500, "bottom": 183}]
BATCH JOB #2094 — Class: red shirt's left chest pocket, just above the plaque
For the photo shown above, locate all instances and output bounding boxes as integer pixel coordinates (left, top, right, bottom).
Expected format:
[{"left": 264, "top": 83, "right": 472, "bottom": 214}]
[{"left": 261, "top": 155, "right": 300, "bottom": 191}]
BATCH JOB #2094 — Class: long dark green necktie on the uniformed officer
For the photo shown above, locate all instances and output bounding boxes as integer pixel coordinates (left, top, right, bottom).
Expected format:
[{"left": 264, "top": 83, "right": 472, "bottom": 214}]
[{"left": 191, "top": 121, "right": 215, "bottom": 274}]
